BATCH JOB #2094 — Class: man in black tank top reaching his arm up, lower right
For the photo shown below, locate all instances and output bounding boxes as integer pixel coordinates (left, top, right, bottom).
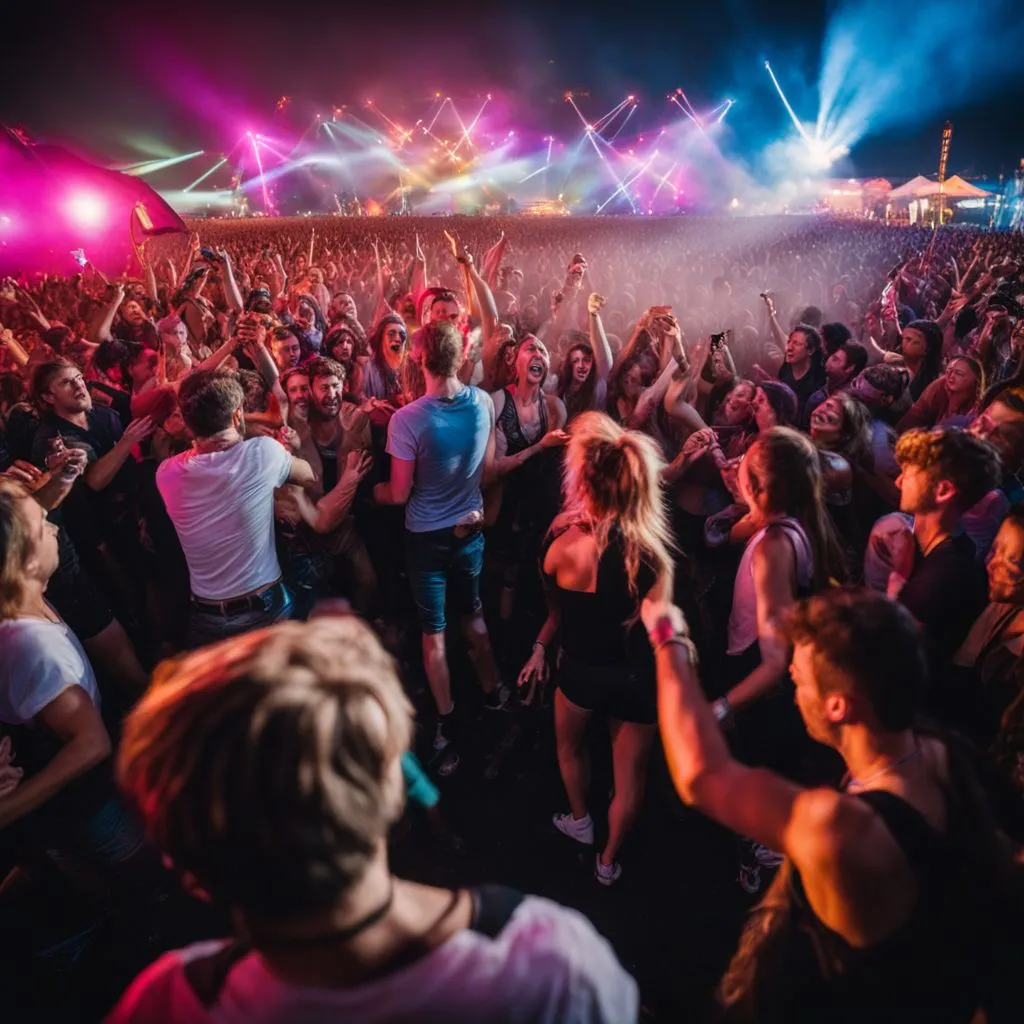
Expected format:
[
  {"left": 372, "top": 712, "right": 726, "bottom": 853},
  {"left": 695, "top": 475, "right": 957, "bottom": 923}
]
[{"left": 641, "top": 588, "right": 1020, "bottom": 1024}]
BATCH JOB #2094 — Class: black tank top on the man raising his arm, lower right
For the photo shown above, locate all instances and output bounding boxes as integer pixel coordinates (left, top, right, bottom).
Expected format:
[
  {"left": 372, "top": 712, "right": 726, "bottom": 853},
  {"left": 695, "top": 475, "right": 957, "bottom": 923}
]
[{"left": 722, "top": 760, "right": 1007, "bottom": 1024}]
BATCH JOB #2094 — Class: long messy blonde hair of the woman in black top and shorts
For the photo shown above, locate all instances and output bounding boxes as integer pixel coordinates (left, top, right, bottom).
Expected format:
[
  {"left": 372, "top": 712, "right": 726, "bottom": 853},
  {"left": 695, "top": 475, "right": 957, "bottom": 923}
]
[{"left": 562, "top": 412, "right": 675, "bottom": 594}]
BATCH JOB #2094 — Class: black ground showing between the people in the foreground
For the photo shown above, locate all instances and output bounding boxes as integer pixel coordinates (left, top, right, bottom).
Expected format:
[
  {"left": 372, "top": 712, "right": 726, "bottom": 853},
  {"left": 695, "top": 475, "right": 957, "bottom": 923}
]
[{"left": 0, "top": 557, "right": 753, "bottom": 1024}]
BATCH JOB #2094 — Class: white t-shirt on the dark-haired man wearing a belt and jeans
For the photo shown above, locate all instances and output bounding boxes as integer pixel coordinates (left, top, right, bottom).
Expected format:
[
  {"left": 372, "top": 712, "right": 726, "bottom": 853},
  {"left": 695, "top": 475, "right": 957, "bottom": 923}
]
[{"left": 157, "top": 437, "right": 292, "bottom": 601}]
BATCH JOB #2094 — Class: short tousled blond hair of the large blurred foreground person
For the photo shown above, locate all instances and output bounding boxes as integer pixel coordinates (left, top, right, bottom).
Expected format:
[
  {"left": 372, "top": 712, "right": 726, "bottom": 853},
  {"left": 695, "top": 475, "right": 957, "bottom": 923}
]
[{"left": 117, "top": 616, "right": 412, "bottom": 919}]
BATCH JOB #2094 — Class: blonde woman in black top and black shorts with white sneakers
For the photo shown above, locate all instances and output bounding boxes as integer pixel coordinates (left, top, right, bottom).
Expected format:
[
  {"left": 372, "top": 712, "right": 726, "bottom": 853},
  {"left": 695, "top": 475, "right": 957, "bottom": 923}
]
[{"left": 519, "top": 412, "right": 672, "bottom": 885}]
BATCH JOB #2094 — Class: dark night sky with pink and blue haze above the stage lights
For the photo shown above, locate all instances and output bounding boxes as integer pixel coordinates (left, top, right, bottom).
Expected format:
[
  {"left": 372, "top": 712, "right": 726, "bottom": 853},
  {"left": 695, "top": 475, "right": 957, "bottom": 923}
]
[{"left": 0, "top": 0, "right": 1024, "bottom": 178}]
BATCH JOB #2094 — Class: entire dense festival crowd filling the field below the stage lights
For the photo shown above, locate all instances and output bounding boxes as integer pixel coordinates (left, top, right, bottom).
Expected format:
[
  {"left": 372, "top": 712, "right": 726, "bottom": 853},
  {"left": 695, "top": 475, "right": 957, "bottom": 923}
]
[{"left": 0, "top": 211, "right": 1024, "bottom": 1021}]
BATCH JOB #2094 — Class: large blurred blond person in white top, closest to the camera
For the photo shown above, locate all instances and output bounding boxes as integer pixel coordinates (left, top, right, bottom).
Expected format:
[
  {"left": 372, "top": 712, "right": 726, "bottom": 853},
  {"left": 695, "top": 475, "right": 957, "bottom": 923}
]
[{"left": 109, "top": 615, "right": 638, "bottom": 1024}]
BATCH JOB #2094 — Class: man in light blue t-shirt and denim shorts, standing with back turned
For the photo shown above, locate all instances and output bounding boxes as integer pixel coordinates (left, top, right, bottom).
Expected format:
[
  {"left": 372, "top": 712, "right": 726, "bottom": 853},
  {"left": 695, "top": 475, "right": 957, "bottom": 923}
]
[{"left": 374, "top": 322, "right": 509, "bottom": 774}]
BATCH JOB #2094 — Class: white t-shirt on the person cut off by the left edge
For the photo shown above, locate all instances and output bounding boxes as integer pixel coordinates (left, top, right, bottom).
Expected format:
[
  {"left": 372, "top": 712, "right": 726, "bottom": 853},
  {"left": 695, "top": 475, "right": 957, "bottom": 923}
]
[{"left": 0, "top": 618, "right": 99, "bottom": 725}]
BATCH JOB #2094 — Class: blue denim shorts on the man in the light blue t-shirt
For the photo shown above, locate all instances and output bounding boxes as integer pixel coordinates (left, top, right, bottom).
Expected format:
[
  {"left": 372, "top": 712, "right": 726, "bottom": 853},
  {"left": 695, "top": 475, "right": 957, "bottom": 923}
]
[{"left": 406, "top": 526, "right": 483, "bottom": 634}]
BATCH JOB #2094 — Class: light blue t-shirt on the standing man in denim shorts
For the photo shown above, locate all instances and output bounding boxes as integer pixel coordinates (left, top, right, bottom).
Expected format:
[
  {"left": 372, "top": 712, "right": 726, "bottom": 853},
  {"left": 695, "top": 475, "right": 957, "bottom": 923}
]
[{"left": 387, "top": 387, "right": 495, "bottom": 534}]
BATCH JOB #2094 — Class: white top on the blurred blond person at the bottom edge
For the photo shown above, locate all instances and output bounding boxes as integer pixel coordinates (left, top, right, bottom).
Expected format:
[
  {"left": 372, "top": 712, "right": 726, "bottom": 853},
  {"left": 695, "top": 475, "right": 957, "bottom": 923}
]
[{"left": 108, "top": 896, "right": 639, "bottom": 1024}]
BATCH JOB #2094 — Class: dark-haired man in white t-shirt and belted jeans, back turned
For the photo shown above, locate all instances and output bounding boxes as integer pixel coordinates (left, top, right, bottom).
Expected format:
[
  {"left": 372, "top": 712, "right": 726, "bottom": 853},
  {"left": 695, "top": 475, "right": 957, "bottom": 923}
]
[{"left": 157, "top": 371, "right": 313, "bottom": 647}]
